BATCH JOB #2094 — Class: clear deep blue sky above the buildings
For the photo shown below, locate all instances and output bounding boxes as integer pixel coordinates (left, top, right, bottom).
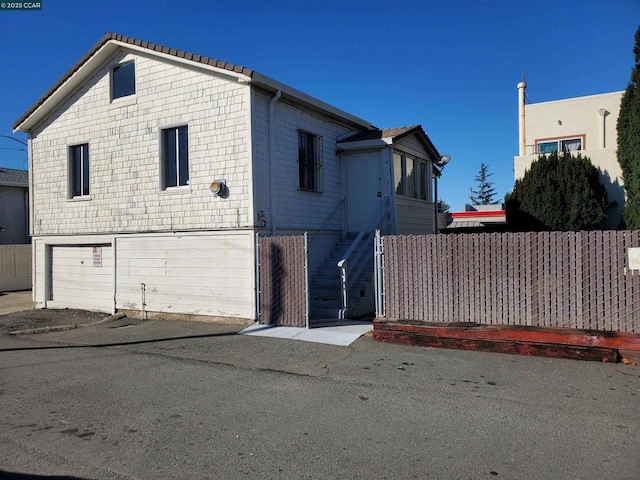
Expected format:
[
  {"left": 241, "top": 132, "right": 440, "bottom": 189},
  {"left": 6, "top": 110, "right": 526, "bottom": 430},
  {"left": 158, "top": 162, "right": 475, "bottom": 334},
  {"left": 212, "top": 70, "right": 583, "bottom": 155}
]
[{"left": 0, "top": 0, "right": 640, "bottom": 210}]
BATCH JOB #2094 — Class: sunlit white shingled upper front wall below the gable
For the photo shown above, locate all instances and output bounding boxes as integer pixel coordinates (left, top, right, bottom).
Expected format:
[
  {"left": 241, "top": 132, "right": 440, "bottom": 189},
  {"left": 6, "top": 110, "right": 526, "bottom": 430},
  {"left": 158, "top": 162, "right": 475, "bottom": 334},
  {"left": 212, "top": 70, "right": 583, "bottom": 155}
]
[{"left": 31, "top": 48, "right": 253, "bottom": 236}]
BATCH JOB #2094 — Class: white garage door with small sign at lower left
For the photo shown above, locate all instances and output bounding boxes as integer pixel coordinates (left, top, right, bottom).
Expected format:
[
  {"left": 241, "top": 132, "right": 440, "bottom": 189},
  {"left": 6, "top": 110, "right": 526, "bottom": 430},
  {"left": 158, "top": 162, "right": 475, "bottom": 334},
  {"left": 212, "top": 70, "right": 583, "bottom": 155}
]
[{"left": 48, "top": 245, "right": 113, "bottom": 312}]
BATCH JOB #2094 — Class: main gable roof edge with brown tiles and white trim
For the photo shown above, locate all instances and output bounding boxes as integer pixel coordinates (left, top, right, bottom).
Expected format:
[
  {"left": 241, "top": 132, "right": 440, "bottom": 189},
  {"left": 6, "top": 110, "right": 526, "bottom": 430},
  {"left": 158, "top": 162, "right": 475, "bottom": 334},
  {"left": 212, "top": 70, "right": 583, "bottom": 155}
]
[{"left": 12, "top": 32, "right": 373, "bottom": 132}]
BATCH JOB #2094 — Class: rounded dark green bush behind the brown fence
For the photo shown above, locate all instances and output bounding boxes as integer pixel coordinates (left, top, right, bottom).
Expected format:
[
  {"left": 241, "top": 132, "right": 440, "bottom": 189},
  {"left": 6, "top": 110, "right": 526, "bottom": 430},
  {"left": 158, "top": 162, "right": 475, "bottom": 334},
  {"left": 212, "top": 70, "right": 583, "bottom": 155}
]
[{"left": 507, "top": 152, "right": 609, "bottom": 232}]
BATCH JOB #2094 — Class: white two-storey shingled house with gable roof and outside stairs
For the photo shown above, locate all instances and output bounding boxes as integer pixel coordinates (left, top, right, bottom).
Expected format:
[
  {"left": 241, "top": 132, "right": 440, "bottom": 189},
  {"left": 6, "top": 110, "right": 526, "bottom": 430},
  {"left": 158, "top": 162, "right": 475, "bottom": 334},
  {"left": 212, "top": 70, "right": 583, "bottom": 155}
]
[{"left": 13, "top": 33, "right": 440, "bottom": 319}]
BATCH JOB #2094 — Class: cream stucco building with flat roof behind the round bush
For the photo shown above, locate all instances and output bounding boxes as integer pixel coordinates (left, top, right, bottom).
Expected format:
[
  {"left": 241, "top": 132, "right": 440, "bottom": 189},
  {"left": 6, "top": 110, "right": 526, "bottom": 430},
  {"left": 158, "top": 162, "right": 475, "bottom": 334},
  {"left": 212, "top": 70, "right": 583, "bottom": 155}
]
[{"left": 513, "top": 82, "right": 624, "bottom": 228}]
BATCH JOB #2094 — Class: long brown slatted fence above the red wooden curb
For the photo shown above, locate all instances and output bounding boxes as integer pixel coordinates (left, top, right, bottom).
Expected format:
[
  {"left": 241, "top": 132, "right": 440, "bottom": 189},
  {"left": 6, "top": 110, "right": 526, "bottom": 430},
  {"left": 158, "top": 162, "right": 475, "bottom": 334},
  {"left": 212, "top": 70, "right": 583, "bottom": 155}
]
[{"left": 383, "top": 231, "right": 640, "bottom": 333}]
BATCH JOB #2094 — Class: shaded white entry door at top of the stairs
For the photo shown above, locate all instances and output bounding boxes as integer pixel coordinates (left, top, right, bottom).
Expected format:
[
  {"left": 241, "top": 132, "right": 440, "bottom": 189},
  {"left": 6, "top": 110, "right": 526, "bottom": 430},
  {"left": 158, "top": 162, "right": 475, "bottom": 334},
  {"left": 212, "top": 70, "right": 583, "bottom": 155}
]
[{"left": 347, "top": 151, "right": 382, "bottom": 232}]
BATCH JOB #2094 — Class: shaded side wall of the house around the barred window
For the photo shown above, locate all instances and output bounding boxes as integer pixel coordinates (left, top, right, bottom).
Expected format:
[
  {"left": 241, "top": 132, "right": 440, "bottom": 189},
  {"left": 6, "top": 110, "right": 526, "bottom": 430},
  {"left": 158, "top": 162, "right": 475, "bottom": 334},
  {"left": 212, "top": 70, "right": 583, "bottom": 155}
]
[{"left": 251, "top": 90, "right": 351, "bottom": 233}]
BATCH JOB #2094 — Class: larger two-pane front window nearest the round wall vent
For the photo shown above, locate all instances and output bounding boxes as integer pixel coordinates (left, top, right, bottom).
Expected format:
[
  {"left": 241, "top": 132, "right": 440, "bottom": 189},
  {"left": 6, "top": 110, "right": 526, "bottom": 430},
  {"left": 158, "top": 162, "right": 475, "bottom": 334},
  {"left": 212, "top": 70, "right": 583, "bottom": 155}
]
[{"left": 162, "top": 125, "right": 189, "bottom": 189}]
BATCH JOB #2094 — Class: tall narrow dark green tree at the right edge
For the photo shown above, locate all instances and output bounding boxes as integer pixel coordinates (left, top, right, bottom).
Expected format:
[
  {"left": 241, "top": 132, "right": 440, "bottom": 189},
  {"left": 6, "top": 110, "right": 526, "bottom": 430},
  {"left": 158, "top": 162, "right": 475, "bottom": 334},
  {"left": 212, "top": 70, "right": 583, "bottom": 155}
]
[{"left": 618, "top": 27, "right": 640, "bottom": 230}]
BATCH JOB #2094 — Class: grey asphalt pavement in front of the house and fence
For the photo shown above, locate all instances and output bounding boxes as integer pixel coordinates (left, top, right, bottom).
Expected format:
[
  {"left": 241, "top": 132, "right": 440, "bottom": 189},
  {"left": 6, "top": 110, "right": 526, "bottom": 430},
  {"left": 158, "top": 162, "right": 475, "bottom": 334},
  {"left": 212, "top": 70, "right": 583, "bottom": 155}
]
[{"left": 0, "top": 319, "right": 640, "bottom": 480}]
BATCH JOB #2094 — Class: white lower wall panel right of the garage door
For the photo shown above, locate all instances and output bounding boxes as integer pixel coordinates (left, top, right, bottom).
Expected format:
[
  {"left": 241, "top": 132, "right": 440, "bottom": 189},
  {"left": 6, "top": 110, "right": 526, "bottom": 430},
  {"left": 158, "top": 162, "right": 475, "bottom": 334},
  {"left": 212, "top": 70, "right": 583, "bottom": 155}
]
[{"left": 116, "top": 232, "right": 255, "bottom": 319}]
